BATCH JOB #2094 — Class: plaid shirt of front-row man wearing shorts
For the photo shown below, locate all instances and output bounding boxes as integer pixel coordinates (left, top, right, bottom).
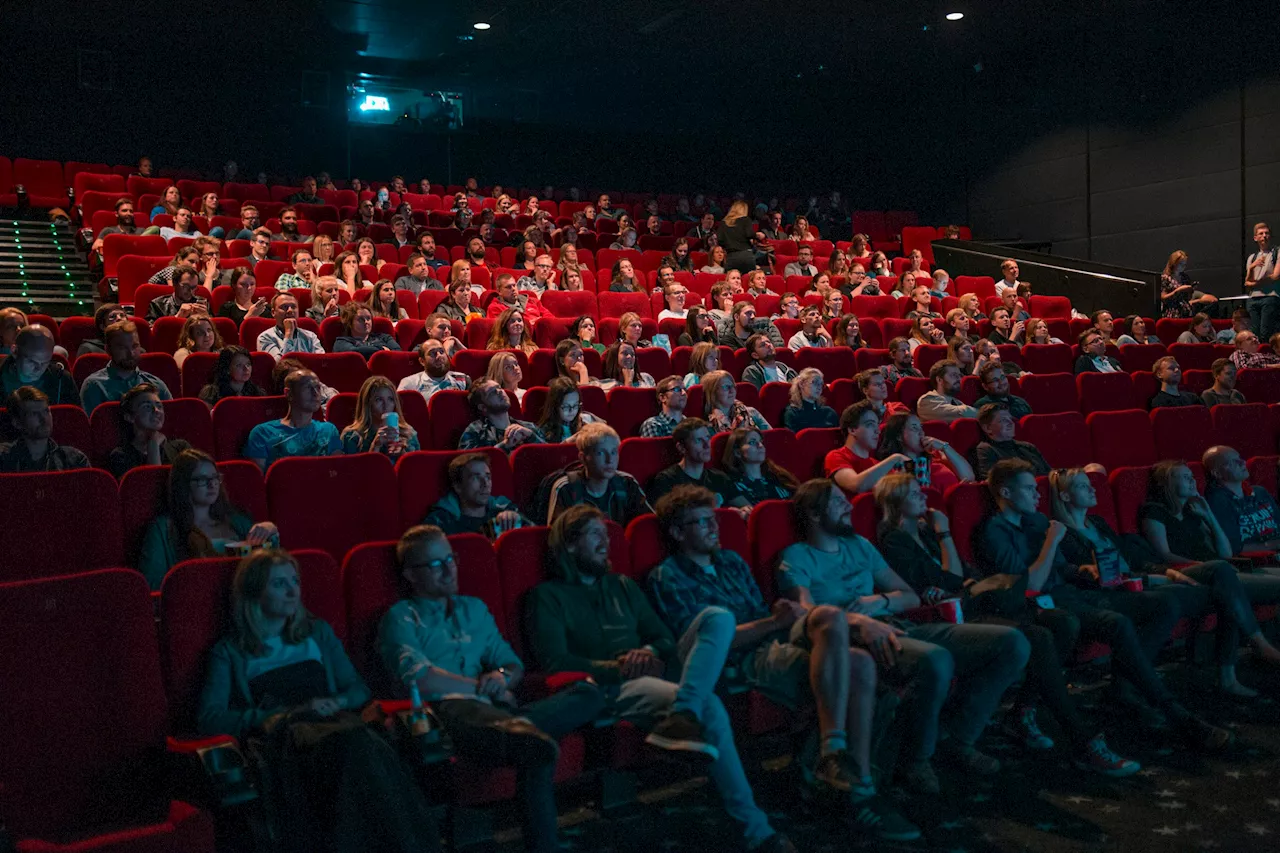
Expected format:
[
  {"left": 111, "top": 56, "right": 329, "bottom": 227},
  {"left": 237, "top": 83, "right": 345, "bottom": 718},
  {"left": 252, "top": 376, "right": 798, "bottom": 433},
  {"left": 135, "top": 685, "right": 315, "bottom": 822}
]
[{"left": 649, "top": 551, "right": 769, "bottom": 637}]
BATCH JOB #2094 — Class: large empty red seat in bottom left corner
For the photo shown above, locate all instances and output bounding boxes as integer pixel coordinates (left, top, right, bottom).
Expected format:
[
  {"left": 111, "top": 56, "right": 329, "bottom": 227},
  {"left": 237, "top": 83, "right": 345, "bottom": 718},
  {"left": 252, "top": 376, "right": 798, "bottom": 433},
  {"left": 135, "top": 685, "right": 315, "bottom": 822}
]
[{"left": 0, "top": 569, "right": 215, "bottom": 853}]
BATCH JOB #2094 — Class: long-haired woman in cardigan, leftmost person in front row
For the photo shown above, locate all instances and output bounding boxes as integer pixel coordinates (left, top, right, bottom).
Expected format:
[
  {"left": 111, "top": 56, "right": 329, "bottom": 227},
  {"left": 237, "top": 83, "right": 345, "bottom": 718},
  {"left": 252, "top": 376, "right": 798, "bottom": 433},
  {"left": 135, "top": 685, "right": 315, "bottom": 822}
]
[{"left": 197, "top": 549, "right": 439, "bottom": 853}]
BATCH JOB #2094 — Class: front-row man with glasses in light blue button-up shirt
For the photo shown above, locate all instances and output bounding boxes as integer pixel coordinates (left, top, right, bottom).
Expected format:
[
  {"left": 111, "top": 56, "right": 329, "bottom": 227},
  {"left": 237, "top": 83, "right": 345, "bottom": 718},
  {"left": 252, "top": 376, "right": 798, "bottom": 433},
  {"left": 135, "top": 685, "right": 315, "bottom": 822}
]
[{"left": 378, "top": 525, "right": 604, "bottom": 853}]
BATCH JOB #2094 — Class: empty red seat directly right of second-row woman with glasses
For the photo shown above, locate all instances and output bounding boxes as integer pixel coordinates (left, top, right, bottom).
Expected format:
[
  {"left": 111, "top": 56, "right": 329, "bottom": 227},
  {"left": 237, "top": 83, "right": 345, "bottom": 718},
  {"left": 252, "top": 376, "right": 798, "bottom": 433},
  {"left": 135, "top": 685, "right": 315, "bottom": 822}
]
[{"left": 266, "top": 453, "right": 401, "bottom": 560}]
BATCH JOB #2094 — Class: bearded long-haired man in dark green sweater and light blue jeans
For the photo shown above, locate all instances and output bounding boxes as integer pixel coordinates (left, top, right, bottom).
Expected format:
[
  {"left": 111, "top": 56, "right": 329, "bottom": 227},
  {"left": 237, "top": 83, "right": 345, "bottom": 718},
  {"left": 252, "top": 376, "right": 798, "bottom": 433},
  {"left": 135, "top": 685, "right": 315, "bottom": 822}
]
[{"left": 527, "top": 506, "right": 795, "bottom": 853}]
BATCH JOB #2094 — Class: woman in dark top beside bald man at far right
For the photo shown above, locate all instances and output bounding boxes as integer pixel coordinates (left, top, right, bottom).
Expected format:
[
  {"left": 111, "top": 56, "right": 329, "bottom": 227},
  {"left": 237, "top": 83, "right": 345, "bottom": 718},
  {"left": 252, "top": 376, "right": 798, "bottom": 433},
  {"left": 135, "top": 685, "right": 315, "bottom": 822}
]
[{"left": 1136, "top": 461, "right": 1280, "bottom": 697}]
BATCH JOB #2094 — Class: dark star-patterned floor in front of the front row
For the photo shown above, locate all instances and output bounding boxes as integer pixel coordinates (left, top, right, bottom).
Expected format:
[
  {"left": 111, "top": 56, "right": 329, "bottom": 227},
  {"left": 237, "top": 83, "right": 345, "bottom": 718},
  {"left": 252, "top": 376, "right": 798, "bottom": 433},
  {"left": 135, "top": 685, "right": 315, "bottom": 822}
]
[{"left": 483, "top": 653, "right": 1280, "bottom": 853}]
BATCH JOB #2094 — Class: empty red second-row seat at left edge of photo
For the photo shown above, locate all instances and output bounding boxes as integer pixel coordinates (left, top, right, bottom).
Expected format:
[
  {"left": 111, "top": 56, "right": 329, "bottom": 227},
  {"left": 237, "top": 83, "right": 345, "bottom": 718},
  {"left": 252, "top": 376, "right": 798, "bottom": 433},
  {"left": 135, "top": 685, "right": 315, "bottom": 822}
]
[{"left": 0, "top": 466, "right": 124, "bottom": 583}]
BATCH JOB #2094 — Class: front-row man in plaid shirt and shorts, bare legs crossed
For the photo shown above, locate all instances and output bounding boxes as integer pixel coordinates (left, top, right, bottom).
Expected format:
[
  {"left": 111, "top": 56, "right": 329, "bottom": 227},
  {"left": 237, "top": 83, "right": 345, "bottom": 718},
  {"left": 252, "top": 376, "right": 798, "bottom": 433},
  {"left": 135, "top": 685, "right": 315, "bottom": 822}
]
[{"left": 649, "top": 485, "right": 920, "bottom": 841}]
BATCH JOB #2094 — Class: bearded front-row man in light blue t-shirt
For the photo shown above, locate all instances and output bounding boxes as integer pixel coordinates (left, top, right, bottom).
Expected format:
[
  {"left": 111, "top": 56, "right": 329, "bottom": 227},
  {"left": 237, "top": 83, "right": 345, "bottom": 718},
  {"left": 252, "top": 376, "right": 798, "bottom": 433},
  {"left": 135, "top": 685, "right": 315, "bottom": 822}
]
[{"left": 777, "top": 480, "right": 1030, "bottom": 794}]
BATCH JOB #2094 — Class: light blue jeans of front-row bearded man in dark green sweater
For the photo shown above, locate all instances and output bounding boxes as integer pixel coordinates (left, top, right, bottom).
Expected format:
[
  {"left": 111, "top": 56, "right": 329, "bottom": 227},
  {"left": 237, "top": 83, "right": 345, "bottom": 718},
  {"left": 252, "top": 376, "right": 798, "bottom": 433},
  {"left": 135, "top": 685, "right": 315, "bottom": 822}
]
[{"left": 611, "top": 607, "right": 773, "bottom": 847}]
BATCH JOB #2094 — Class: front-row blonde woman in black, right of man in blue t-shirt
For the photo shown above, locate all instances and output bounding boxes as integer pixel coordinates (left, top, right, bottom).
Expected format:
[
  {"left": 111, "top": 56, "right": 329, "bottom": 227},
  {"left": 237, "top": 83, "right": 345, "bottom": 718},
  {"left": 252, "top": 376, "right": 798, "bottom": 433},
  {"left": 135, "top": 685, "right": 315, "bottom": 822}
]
[{"left": 876, "top": 473, "right": 1142, "bottom": 777}]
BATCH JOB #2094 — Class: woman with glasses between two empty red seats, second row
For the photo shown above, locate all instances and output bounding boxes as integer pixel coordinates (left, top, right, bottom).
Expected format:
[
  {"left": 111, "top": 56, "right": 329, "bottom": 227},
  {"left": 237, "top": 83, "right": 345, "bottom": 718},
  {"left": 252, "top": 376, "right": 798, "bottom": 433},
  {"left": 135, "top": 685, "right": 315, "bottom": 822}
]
[{"left": 138, "top": 450, "right": 279, "bottom": 589}]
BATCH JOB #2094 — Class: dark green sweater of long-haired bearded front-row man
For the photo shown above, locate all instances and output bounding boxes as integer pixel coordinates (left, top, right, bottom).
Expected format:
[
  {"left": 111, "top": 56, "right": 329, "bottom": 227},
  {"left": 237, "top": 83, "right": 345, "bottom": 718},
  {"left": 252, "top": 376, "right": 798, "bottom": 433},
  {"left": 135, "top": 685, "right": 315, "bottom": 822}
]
[{"left": 526, "top": 555, "right": 676, "bottom": 684}]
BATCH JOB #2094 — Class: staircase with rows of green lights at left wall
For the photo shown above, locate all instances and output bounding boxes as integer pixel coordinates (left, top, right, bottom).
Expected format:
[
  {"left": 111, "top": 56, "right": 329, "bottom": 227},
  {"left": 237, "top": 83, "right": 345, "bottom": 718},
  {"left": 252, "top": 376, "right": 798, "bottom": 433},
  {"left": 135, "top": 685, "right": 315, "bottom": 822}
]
[{"left": 0, "top": 218, "right": 95, "bottom": 316}]
